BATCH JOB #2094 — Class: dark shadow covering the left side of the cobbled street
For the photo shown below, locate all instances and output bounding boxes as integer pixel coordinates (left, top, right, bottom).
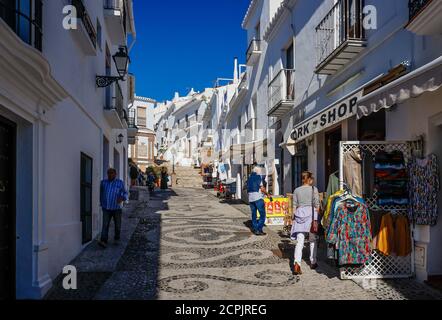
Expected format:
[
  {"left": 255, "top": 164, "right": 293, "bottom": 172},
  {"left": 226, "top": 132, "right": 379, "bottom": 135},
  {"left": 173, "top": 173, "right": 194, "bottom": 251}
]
[{"left": 45, "top": 187, "right": 177, "bottom": 300}]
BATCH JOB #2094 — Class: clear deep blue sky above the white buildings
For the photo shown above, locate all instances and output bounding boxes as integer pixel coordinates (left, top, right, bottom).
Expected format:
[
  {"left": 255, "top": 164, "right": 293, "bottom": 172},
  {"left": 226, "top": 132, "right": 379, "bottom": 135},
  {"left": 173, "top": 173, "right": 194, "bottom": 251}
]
[{"left": 130, "top": 0, "right": 250, "bottom": 101}]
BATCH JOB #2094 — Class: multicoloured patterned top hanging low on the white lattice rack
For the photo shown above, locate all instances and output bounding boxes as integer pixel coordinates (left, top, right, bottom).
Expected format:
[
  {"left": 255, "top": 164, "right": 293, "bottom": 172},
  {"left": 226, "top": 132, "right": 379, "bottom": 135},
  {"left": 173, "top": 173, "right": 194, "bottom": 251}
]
[{"left": 327, "top": 201, "right": 372, "bottom": 265}]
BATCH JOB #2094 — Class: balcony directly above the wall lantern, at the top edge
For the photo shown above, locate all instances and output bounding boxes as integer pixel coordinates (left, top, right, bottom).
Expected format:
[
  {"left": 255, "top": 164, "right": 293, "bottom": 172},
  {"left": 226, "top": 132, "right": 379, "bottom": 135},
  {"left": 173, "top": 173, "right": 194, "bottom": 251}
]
[{"left": 104, "top": 0, "right": 127, "bottom": 45}]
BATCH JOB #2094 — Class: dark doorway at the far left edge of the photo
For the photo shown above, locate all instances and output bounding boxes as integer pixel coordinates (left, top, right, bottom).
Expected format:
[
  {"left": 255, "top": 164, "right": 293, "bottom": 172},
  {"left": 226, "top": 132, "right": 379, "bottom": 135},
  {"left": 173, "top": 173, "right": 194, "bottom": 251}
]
[{"left": 0, "top": 116, "right": 16, "bottom": 300}]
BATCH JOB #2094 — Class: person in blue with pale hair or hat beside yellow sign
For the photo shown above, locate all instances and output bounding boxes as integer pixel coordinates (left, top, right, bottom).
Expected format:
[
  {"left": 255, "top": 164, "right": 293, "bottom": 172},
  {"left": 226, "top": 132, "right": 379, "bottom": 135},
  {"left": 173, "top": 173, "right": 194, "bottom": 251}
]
[{"left": 247, "top": 165, "right": 269, "bottom": 236}]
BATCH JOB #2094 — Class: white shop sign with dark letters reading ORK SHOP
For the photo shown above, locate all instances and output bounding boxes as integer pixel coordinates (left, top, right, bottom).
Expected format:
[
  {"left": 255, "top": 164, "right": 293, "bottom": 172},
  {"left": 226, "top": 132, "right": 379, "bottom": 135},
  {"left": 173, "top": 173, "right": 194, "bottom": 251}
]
[{"left": 290, "top": 90, "right": 363, "bottom": 141}]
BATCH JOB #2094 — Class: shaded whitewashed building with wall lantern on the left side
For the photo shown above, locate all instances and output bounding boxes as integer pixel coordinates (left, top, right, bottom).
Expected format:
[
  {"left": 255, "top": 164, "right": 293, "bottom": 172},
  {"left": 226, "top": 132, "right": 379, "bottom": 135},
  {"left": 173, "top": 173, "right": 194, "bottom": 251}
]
[{"left": 0, "top": 0, "right": 135, "bottom": 299}]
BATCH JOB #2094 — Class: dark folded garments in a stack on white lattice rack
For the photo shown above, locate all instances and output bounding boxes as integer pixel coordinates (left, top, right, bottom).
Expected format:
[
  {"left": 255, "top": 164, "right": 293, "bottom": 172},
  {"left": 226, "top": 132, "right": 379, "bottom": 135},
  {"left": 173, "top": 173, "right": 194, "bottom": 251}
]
[{"left": 374, "top": 151, "right": 408, "bottom": 206}]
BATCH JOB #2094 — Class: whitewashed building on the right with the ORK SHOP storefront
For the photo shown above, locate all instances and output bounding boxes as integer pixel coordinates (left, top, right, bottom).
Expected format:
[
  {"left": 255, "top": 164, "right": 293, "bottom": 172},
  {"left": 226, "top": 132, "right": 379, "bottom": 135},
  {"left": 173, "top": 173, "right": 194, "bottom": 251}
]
[{"left": 243, "top": 0, "right": 442, "bottom": 280}]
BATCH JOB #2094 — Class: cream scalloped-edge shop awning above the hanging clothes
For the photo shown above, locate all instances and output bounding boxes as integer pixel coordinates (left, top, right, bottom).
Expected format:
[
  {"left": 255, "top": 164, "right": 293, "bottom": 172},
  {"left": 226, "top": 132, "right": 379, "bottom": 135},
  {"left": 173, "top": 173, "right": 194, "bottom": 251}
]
[{"left": 357, "top": 56, "right": 442, "bottom": 119}]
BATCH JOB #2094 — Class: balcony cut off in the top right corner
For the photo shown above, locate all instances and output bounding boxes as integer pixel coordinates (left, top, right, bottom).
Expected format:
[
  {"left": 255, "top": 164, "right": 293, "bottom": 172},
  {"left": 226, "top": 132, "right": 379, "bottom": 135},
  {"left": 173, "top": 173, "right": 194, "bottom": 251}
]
[{"left": 406, "top": 0, "right": 442, "bottom": 36}]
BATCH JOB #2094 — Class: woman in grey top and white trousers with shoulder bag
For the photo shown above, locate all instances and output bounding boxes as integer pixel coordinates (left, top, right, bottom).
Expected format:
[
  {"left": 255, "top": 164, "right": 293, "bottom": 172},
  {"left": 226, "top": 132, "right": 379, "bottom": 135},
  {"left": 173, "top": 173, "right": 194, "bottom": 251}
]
[{"left": 291, "top": 171, "right": 320, "bottom": 274}]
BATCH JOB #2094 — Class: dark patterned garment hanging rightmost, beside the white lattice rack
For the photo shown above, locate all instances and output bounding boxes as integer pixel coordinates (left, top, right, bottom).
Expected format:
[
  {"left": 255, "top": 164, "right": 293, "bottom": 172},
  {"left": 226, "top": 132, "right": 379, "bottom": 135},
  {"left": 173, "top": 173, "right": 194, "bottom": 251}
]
[{"left": 408, "top": 154, "right": 440, "bottom": 226}]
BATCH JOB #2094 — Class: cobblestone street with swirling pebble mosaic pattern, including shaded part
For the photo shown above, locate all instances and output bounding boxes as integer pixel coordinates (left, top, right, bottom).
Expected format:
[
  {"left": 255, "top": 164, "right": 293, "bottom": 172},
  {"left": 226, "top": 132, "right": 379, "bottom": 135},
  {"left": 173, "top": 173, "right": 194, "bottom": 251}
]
[{"left": 46, "top": 188, "right": 442, "bottom": 300}]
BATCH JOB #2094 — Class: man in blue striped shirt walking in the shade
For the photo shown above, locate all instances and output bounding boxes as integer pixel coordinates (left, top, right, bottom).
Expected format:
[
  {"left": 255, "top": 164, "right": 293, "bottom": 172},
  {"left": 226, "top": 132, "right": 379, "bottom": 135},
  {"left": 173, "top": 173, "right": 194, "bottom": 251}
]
[{"left": 98, "top": 168, "right": 127, "bottom": 248}]
